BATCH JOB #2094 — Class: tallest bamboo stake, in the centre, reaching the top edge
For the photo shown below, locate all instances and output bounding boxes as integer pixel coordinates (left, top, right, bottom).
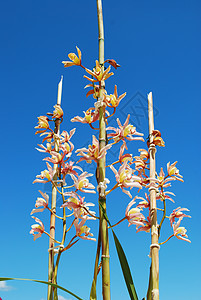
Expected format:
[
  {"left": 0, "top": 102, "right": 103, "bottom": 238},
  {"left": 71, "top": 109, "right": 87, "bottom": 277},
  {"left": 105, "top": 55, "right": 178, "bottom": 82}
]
[{"left": 97, "top": 0, "right": 110, "bottom": 300}]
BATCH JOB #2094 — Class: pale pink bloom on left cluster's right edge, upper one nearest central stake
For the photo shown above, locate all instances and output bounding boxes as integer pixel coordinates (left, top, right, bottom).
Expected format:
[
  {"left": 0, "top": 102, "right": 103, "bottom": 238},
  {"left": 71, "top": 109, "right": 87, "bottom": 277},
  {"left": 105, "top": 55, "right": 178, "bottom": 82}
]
[{"left": 70, "top": 172, "right": 96, "bottom": 194}]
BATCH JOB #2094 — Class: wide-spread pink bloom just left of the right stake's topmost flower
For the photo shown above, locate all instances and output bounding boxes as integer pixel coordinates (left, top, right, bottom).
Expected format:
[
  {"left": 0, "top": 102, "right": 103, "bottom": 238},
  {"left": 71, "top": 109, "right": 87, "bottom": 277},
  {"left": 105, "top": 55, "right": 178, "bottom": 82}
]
[{"left": 106, "top": 115, "right": 144, "bottom": 149}]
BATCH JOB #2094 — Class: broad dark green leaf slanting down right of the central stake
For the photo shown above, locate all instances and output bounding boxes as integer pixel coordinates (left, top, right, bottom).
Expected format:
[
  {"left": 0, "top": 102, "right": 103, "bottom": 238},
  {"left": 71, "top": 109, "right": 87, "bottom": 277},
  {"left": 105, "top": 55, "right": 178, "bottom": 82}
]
[{"left": 112, "top": 230, "right": 138, "bottom": 300}]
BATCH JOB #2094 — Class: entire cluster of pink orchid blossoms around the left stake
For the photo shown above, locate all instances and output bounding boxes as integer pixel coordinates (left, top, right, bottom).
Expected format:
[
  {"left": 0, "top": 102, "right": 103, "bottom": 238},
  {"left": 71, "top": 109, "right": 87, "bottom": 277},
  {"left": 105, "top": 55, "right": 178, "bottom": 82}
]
[{"left": 30, "top": 105, "right": 96, "bottom": 248}]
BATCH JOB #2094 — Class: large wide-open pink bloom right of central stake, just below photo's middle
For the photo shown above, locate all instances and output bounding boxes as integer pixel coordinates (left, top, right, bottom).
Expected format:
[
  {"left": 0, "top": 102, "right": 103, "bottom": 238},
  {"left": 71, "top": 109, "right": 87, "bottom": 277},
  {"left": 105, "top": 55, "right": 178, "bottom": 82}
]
[{"left": 110, "top": 160, "right": 142, "bottom": 198}]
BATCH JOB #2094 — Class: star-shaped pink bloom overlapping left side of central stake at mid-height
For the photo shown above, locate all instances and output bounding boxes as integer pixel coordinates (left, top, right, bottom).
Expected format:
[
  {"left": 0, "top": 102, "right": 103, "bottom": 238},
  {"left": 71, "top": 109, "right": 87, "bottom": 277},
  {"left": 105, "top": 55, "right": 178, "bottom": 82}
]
[{"left": 75, "top": 135, "right": 112, "bottom": 163}]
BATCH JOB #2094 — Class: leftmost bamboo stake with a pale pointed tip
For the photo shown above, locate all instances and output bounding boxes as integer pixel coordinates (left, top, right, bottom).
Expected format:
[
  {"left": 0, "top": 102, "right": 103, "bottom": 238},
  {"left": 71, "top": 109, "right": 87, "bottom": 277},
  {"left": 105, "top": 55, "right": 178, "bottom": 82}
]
[{"left": 47, "top": 77, "right": 63, "bottom": 300}]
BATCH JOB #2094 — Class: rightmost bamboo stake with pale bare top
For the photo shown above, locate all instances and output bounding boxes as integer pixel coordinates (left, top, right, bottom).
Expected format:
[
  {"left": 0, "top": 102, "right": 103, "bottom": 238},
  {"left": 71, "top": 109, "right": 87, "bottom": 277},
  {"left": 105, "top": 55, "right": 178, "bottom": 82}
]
[{"left": 147, "top": 92, "right": 159, "bottom": 300}]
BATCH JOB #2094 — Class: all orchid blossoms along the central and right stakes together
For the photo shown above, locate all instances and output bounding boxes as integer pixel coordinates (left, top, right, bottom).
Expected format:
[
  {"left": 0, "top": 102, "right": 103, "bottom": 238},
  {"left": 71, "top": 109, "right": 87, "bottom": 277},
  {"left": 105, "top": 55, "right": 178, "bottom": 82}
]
[{"left": 60, "top": 47, "right": 190, "bottom": 244}]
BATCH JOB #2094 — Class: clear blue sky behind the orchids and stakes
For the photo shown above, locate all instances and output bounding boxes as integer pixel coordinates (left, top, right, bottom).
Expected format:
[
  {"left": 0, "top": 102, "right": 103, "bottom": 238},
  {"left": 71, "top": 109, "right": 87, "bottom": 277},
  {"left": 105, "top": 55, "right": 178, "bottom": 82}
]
[{"left": 0, "top": 0, "right": 201, "bottom": 300}]
